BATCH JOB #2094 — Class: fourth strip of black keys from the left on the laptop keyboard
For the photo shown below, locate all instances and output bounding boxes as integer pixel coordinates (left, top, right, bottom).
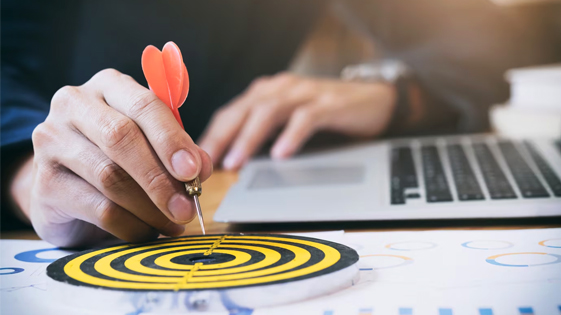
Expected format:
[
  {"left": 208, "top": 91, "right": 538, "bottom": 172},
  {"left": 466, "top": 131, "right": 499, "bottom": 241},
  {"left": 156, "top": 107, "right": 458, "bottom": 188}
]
[{"left": 472, "top": 143, "right": 517, "bottom": 199}]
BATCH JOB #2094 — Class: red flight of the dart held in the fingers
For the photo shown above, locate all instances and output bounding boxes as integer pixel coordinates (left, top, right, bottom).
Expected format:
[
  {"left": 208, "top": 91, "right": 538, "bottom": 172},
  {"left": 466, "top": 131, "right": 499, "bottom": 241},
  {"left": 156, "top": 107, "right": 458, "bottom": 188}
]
[{"left": 142, "top": 42, "right": 189, "bottom": 128}]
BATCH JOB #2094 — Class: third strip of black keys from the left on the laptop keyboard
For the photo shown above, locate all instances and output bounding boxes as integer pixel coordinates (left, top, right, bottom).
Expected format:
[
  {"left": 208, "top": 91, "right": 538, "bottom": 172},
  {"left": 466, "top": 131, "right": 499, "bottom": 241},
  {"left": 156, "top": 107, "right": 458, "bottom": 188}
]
[{"left": 447, "top": 144, "right": 485, "bottom": 201}]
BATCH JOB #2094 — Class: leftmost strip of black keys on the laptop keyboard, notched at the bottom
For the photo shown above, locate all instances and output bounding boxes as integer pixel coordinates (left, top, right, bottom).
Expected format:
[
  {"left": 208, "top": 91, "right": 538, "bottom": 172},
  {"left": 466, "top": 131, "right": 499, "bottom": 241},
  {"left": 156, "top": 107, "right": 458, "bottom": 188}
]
[{"left": 390, "top": 147, "right": 419, "bottom": 205}]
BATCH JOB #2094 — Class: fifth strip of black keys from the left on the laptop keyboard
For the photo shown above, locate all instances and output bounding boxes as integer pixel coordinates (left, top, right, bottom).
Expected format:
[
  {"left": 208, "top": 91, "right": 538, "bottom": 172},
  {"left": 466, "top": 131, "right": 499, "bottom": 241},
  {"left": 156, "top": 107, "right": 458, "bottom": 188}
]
[{"left": 498, "top": 141, "right": 549, "bottom": 198}]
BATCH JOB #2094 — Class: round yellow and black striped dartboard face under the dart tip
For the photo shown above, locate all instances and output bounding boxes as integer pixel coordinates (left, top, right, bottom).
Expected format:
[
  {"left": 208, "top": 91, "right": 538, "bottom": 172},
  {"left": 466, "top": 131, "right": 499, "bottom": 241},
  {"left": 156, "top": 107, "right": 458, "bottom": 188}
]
[{"left": 47, "top": 234, "right": 358, "bottom": 291}]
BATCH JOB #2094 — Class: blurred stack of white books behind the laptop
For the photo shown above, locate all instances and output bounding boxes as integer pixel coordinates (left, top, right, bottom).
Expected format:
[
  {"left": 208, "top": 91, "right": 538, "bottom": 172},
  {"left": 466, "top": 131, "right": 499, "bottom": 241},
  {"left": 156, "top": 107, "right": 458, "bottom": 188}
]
[{"left": 490, "top": 64, "right": 561, "bottom": 138}]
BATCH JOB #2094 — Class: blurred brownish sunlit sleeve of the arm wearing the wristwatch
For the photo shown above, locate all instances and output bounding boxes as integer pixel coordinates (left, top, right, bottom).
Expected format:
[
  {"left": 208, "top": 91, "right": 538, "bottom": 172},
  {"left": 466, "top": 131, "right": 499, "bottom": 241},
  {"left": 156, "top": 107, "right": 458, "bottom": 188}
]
[{"left": 339, "top": 0, "right": 555, "bottom": 132}]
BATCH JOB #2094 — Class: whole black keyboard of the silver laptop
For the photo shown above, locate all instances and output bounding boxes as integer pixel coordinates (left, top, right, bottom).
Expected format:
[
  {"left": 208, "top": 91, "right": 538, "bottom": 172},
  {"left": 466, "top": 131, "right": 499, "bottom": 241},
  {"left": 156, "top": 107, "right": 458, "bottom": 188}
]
[{"left": 391, "top": 141, "right": 561, "bottom": 205}]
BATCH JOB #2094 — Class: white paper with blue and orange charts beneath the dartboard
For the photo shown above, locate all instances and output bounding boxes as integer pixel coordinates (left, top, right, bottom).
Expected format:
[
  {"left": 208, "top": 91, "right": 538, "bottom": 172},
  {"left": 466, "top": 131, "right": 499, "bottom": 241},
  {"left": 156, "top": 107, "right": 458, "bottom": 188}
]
[{"left": 0, "top": 229, "right": 561, "bottom": 315}]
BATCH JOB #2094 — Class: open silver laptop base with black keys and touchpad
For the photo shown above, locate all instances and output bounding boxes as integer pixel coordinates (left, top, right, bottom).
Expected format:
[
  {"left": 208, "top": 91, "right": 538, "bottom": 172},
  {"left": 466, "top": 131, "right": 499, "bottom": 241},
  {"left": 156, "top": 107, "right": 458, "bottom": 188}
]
[{"left": 214, "top": 134, "right": 561, "bottom": 223}]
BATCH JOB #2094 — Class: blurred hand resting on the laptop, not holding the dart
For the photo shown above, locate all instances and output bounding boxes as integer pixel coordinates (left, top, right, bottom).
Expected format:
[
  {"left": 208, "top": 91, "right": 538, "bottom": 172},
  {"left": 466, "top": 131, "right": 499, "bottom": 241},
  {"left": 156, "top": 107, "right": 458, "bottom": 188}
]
[{"left": 200, "top": 73, "right": 396, "bottom": 169}]
